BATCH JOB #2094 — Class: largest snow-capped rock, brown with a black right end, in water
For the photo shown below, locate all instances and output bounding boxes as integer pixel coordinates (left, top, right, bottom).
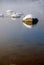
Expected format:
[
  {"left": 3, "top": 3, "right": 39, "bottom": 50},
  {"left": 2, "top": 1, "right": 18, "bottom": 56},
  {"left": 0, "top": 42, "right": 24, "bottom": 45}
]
[{"left": 23, "top": 15, "right": 38, "bottom": 25}]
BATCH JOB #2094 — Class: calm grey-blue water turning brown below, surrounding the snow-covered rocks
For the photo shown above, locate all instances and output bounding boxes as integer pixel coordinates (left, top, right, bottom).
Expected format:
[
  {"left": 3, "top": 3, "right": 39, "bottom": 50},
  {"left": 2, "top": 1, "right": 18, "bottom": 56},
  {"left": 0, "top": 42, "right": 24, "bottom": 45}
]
[{"left": 0, "top": 0, "right": 44, "bottom": 65}]
